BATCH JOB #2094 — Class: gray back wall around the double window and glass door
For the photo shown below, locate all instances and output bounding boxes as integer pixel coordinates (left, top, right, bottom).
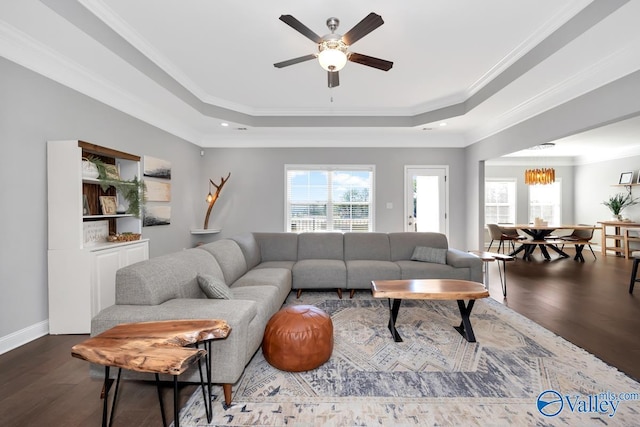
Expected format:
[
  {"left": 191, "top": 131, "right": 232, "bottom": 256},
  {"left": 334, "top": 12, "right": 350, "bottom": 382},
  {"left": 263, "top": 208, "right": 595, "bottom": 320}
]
[{"left": 198, "top": 148, "right": 466, "bottom": 249}]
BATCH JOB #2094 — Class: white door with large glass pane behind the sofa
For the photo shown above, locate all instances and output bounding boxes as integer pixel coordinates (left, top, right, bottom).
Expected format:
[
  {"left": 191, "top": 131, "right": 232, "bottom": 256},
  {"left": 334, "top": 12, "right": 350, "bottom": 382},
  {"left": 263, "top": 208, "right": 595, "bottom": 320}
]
[{"left": 404, "top": 166, "right": 449, "bottom": 234}]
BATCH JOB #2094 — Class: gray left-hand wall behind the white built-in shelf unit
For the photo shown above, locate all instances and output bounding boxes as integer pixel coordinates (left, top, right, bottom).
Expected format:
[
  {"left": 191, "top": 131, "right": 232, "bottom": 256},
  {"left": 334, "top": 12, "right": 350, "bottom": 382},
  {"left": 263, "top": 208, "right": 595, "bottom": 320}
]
[{"left": 0, "top": 58, "right": 201, "bottom": 339}]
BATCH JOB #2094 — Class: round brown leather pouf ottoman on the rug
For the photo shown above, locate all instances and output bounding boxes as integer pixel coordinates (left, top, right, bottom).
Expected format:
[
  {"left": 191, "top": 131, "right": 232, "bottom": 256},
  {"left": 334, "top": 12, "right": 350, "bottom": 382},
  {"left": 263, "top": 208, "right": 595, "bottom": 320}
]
[{"left": 262, "top": 305, "right": 333, "bottom": 372}]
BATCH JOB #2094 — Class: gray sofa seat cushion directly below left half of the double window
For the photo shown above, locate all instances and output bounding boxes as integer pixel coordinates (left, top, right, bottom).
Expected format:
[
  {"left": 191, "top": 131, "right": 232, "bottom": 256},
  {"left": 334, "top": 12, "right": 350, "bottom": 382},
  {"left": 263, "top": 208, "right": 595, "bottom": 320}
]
[{"left": 291, "top": 259, "right": 347, "bottom": 289}]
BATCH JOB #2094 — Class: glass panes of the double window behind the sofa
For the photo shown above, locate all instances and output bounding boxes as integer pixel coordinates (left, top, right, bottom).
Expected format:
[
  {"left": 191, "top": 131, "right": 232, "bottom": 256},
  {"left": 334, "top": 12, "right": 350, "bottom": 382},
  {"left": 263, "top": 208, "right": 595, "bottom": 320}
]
[{"left": 285, "top": 165, "right": 374, "bottom": 233}]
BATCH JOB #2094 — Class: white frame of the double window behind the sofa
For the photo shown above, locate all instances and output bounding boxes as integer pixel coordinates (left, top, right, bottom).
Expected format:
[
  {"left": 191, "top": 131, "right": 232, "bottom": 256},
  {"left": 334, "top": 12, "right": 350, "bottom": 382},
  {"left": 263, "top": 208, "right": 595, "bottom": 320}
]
[{"left": 284, "top": 164, "right": 376, "bottom": 233}]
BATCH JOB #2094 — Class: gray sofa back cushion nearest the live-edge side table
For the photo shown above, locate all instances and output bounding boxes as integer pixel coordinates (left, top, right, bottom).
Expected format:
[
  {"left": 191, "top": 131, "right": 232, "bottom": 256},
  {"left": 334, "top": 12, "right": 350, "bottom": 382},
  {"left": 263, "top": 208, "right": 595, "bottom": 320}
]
[{"left": 116, "top": 249, "right": 223, "bottom": 305}]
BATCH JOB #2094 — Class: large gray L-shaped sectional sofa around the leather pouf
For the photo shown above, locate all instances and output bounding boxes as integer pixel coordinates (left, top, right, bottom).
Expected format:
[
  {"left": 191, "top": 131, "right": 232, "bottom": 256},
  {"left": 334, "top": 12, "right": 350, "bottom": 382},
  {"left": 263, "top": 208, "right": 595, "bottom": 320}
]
[{"left": 91, "top": 233, "right": 482, "bottom": 404}]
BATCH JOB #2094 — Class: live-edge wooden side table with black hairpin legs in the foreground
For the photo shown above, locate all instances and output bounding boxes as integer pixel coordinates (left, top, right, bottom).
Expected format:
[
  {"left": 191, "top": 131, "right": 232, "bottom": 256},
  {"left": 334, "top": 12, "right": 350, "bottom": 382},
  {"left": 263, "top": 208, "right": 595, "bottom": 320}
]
[{"left": 71, "top": 319, "right": 231, "bottom": 427}]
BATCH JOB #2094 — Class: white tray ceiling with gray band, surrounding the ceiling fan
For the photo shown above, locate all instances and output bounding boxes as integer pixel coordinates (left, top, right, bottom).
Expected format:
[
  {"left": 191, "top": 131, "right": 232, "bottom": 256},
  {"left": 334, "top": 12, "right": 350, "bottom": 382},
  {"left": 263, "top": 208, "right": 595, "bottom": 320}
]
[{"left": 0, "top": 0, "right": 640, "bottom": 155}]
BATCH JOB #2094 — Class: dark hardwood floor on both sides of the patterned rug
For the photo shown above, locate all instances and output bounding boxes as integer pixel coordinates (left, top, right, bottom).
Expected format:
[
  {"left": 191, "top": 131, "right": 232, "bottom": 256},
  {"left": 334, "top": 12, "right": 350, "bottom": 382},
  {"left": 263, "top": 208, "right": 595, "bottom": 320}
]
[{"left": 0, "top": 247, "right": 640, "bottom": 427}]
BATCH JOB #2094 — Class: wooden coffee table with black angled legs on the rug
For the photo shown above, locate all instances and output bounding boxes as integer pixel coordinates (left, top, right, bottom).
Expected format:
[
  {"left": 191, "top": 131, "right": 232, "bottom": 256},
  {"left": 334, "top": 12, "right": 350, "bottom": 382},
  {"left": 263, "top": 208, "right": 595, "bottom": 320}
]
[{"left": 371, "top": 279, "right": 489, "bottom": 342}]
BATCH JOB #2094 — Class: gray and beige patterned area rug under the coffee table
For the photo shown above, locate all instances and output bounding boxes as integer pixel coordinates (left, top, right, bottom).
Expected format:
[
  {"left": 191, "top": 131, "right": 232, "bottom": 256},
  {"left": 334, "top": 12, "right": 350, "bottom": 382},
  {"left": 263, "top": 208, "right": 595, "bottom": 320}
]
[{"left": 180, "top": 292, "right": 640, "bottom": 426}]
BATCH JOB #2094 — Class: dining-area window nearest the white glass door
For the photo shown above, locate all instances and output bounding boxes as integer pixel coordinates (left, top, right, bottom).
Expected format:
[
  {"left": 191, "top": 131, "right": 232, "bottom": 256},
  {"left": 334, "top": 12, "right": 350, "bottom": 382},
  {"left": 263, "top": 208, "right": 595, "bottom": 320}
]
[{"left": 484, "top": 178, "right": 516, "bottom": 224}]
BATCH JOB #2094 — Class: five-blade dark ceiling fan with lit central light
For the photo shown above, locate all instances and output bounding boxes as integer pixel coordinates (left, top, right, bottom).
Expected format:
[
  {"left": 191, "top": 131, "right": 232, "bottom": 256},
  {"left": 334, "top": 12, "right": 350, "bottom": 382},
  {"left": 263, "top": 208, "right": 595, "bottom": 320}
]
[{"left": 273, "top": 12, "right": 393, "bottom": 88}]
